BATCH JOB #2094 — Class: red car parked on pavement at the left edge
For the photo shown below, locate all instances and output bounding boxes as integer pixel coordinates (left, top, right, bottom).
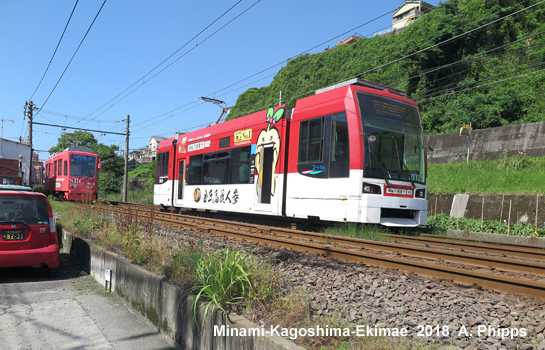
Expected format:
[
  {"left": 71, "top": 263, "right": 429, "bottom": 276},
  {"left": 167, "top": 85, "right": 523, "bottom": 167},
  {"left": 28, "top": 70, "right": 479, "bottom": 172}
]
[{"left": 0, "top": 185, "right": 59, "bottom": 277}]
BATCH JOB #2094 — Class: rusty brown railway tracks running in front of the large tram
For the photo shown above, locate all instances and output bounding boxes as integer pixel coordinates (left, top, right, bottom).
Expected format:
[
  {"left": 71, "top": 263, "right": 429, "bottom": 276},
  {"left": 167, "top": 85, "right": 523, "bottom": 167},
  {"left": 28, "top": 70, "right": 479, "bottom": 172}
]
[{"left": 92, "top": 204, "right": 545, "bottom": 299}]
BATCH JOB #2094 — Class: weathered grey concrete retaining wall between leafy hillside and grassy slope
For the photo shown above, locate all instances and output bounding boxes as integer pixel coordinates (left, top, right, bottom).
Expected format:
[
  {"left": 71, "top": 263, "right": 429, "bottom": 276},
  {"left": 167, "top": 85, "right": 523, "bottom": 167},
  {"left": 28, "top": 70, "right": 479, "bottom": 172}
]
[{"left": 426, "top": 122, "right": 545, "bottom": 164}]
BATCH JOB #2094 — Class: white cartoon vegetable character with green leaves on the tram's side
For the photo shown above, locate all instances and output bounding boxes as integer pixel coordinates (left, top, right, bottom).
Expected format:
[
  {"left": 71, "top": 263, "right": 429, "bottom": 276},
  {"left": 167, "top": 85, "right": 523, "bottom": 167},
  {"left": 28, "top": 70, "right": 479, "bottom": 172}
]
[{"left": 255, "top": 107, "right": 284, "bottom": 202}]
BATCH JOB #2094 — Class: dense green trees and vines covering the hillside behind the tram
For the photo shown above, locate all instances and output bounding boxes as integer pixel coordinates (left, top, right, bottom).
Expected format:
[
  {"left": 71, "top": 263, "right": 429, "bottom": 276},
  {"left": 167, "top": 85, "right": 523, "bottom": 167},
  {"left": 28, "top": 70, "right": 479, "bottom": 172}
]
[{"left": 225, "top": 0, "right": 545, "bottom": 134}]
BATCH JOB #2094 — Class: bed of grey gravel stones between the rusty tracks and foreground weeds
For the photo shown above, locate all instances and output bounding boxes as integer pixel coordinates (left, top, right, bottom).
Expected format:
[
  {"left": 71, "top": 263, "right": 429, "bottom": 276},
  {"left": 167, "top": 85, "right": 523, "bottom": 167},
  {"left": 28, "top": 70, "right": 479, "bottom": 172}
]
[{"left": 155, "top": 226, "right": 545, "bottom": 350}]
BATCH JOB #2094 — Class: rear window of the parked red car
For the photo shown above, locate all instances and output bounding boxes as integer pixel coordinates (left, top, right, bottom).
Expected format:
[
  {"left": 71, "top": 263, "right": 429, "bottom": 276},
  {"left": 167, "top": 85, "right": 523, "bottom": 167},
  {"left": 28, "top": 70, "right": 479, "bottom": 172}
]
[{"left": 0, "top": 196, "right": 49, "bottom": 225}]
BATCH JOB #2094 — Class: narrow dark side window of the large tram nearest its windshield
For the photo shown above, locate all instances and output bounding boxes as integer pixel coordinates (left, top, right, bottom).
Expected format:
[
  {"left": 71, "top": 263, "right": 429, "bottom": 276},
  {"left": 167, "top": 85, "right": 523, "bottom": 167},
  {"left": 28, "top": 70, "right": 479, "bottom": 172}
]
[{"left": 329, "top": 113, "right": 350, "bottom": 177}]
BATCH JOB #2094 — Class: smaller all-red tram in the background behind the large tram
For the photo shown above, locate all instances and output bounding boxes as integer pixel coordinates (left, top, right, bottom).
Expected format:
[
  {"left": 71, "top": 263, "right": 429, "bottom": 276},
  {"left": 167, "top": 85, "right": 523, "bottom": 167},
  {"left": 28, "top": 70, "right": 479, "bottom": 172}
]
[{"left": 45, "top": 146, "right": 99, "bottom": 201}]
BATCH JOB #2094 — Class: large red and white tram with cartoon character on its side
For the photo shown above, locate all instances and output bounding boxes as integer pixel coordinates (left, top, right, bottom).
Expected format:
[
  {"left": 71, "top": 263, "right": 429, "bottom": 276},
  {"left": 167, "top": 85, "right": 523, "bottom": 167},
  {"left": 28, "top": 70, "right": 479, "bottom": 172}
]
[{"left": 154, "top": 79, "right": 427, "bottom": 226}]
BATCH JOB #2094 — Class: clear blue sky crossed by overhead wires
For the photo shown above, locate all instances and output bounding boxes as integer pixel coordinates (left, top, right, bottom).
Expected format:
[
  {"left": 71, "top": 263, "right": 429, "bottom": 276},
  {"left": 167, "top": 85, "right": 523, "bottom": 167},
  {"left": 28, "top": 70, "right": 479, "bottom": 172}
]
[{"left": 0, "top": 0, "right": 438, "bottom": 160}]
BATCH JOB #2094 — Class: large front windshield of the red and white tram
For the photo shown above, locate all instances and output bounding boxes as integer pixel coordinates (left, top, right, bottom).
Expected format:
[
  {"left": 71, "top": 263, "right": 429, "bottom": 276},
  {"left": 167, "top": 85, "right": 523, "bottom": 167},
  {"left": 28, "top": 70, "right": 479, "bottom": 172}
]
[{"left": 357, "top": 92, "right": 426, "bottom": 183}]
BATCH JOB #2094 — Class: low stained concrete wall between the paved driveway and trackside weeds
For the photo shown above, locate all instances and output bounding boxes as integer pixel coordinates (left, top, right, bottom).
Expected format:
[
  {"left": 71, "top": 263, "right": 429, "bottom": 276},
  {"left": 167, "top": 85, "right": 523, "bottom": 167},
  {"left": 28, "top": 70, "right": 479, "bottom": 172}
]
[{"left": 62, "top": 229, "right": 304, "bottom": 350}]
